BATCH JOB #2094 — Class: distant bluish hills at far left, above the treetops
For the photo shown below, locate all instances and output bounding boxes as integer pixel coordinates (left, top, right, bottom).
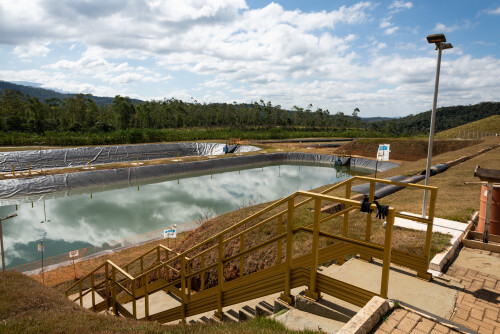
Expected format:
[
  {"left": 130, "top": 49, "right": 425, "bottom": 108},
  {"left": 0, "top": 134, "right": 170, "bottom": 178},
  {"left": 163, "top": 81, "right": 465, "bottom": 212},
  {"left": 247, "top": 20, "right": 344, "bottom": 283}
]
[{"left": 0, "top": 80, "right": 142, "bottom": 106}]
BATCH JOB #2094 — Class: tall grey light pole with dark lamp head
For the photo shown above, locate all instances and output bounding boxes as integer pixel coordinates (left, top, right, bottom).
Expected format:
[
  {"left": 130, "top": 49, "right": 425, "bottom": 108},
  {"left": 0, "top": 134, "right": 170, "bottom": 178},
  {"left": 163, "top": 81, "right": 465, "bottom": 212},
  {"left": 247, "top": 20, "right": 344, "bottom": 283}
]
[{"left": 422, "top": 34, "right": 453, "bottom": 217}]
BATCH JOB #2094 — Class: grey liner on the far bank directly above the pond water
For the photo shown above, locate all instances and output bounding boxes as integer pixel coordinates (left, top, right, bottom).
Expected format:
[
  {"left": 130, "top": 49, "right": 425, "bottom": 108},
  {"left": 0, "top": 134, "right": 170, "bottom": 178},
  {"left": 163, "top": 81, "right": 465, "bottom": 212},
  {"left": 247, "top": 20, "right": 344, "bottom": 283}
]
[{"left": 0, "top": 152, "right": 398, "bottom": 205}]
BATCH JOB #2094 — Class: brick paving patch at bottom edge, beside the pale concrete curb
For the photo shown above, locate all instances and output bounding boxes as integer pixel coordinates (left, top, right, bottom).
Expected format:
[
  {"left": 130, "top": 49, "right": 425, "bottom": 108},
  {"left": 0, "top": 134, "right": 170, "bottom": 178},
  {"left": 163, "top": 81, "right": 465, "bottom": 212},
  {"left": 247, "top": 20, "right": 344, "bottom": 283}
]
[{"left": 372, "top": 308, "right": 459, "bottom": 334}]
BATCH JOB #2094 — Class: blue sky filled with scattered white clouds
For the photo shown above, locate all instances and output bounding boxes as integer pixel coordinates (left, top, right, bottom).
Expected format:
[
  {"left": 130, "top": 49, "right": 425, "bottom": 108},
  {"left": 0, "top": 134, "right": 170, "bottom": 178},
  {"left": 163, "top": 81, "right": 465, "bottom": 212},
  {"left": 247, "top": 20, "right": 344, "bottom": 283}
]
[{"left": 0, "top": 0, "right": 500, "bottom": 117}]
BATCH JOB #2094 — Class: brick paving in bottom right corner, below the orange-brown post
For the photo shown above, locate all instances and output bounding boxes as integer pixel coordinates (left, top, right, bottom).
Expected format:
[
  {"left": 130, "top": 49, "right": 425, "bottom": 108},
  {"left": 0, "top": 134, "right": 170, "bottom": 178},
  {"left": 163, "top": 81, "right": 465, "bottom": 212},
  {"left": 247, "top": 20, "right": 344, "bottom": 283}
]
[{"left": 445, "top": 248, "right": 500, "bottom": 334}]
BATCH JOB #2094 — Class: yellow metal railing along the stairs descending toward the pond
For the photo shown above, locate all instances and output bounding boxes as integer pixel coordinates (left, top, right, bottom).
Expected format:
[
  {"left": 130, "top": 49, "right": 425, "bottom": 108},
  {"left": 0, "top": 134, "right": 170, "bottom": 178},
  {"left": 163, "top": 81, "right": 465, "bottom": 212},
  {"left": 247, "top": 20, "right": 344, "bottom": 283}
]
[{"left": 66, "top": 176, "right": 437, "bottom": 322}]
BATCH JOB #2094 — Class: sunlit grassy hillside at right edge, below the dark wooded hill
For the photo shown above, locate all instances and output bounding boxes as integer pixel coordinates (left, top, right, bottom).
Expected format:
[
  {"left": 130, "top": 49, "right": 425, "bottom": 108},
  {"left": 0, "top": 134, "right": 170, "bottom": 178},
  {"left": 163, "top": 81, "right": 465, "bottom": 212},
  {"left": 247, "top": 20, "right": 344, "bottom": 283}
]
[{"left": 436, "top": 115, "right": 500, "bottom": 139}]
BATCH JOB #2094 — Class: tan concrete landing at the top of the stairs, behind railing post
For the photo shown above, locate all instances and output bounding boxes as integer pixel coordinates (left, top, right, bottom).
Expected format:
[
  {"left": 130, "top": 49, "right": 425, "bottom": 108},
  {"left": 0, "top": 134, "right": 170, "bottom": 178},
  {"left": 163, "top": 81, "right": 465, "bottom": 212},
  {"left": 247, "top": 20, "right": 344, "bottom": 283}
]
[{"left": 328, "top": 258, "right": 458, "bottom": 319}]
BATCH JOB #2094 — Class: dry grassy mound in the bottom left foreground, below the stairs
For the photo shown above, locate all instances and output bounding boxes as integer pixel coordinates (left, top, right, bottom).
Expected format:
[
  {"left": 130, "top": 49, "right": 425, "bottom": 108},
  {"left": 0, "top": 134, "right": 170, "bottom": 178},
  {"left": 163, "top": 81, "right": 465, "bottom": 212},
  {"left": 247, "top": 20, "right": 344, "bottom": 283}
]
[{"left": 0, "top": 272, "right": 313, "bottom": 334}]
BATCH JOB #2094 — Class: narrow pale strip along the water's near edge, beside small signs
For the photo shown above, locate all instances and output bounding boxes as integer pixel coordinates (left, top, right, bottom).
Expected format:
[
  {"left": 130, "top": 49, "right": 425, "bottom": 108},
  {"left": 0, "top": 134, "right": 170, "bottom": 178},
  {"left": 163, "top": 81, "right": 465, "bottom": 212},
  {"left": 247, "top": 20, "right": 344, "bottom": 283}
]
[{"left": 6, "top": 220, "right": 201, "bottom": 276}]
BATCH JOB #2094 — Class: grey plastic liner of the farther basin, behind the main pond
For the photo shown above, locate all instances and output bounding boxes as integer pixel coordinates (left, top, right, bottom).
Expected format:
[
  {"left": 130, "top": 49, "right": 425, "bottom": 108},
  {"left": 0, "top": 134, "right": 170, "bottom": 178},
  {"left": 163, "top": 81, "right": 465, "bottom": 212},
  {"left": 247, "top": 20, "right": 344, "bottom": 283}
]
[{"left": 0, "top": 142, "right": 260, "bottom": 172}]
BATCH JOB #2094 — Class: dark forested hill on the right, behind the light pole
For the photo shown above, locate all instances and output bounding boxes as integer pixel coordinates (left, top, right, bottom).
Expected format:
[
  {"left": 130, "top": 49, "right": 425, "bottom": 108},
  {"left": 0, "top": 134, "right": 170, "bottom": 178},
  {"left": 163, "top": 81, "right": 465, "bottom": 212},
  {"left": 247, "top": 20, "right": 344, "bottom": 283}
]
[{"left": 374, "top": 102, "right": 500, "bottom": 135}]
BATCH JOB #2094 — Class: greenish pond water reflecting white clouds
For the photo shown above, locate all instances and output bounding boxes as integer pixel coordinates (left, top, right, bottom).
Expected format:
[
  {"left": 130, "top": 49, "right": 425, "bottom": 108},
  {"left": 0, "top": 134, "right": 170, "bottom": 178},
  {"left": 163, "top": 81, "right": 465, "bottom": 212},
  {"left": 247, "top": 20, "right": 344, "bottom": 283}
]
[{"left": 0, "top": 165, "right": 360, "bottom": 267}]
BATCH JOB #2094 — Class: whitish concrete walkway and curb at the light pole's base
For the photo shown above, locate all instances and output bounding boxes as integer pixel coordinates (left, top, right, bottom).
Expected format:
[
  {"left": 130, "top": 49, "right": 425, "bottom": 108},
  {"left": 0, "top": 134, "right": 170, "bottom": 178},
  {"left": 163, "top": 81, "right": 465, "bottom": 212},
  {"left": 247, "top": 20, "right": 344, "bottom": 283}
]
[{"left": 394, "top": 212, "right": 469, "bottom": 275}]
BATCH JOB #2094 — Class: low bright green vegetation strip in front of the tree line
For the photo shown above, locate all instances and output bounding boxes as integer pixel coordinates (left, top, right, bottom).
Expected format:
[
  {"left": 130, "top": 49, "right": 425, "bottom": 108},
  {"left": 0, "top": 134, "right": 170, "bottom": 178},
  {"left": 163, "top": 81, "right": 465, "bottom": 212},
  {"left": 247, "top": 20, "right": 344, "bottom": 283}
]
[{"left": 0, "top": 127, "right": 382, "bottom": 146}]
